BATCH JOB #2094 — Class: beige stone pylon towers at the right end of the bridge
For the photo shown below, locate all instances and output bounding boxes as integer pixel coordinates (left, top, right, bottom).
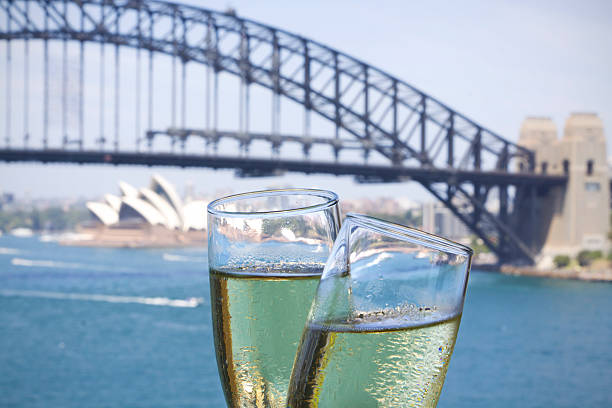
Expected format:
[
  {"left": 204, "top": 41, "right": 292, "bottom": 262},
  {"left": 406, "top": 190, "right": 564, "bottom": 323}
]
[{"left": 518, "top": 113, "right": 610, "bottom": 258}]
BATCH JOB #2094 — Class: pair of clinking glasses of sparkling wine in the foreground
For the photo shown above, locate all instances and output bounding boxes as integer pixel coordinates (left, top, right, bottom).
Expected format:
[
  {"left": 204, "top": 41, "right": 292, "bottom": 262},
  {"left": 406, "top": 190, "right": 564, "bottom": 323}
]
[{"left": 208, "top": 190, "right": 472, "bottom": 408}]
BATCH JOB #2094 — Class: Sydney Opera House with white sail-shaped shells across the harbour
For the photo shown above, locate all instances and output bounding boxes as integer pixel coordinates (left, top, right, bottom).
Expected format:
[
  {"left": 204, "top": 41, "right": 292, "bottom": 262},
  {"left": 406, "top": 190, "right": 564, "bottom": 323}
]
[{"left": 67, "top": 175, "right": 207, "bottom": 247}]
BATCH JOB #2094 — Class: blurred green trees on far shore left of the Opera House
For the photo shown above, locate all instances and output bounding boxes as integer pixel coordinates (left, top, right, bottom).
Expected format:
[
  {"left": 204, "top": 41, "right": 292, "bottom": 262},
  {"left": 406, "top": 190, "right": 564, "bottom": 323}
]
[{"left": 0, "top": 207, "right": 90, "bottom": 232}]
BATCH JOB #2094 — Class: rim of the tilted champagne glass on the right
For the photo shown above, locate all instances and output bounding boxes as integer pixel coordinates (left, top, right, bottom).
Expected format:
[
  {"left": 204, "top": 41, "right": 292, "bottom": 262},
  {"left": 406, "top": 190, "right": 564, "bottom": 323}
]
[{"left": 344, "top": 213, "right": 474, "bottom": 258}]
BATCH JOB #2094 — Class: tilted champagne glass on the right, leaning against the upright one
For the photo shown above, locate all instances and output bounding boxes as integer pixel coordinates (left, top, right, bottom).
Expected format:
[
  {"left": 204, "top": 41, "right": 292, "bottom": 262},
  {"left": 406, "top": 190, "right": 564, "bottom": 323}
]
[{"left": 287, "top": 214, "right": 472, "bottom": 408}]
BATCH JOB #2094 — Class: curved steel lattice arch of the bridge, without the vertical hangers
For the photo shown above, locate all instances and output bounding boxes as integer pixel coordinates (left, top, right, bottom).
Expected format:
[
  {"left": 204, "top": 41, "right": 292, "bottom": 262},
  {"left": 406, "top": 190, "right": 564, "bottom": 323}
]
[{"left": 0, "top": 0, "right": 559, "bottom": 260}]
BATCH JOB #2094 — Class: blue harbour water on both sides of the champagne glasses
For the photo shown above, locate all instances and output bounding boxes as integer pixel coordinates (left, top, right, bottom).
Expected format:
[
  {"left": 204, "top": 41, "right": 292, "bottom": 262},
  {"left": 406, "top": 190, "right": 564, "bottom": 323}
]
[{"left": 0, "top": 236, "right": 612, "bottom": 408}]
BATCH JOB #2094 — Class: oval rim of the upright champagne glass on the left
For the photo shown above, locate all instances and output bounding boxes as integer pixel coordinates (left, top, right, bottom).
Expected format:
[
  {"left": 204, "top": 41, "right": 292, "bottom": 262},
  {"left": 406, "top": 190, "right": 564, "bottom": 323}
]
[{"left": 206, "top": 188, "right": 339, "bottom": 218}]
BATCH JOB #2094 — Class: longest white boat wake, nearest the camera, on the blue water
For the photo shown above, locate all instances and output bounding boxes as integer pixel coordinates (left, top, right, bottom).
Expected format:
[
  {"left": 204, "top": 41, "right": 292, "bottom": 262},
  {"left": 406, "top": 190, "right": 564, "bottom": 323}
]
[{"left": 0, "top": 290, "right": 204, "bottom": 308}]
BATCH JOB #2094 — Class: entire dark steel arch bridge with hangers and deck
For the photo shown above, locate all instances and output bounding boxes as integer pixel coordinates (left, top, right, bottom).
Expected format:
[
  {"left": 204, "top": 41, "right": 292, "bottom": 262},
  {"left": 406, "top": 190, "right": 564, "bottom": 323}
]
[{"left": 0, "top": 0, "right": 566, "bottom": 262}]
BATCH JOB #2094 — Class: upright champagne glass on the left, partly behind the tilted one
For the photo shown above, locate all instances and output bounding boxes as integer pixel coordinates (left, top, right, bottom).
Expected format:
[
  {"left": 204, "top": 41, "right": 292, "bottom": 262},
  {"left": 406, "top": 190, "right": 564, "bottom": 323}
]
[{"left": 208, "top": 189, "right": 340, "bottom": 407}]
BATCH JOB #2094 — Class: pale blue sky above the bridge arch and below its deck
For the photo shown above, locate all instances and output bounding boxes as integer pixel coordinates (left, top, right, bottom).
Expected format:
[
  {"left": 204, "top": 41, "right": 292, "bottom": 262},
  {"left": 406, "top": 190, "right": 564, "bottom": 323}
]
[{"left": 0, "top": 0, "right": 612, "bottom": 199}]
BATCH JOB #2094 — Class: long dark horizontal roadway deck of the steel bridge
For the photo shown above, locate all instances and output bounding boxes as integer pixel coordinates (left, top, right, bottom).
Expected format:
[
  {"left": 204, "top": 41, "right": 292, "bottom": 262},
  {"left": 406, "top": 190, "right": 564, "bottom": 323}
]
[{"left": 0, "top": 149, "right": 567, "bottom": 186}]
